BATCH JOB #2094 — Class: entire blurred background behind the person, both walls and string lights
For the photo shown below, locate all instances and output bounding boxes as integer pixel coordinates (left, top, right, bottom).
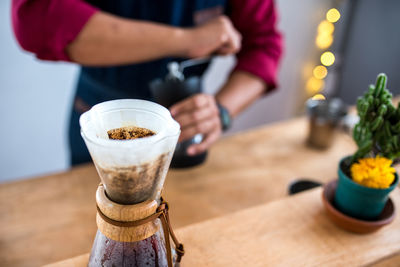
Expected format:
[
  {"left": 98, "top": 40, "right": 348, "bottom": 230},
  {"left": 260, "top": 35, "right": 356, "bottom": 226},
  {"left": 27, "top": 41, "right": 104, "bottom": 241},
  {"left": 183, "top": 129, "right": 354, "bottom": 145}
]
[{"left": 0, "top": 0, "right": 400, "bottom": 182}]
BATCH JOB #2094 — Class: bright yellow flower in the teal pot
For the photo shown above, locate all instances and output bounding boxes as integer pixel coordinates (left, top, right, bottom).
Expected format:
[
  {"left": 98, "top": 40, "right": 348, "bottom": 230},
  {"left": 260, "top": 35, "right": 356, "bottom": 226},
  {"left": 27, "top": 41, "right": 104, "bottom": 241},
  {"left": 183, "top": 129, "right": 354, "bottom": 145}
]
[{"left": 350, "top": 156, "right": 396, "bottom": 189}]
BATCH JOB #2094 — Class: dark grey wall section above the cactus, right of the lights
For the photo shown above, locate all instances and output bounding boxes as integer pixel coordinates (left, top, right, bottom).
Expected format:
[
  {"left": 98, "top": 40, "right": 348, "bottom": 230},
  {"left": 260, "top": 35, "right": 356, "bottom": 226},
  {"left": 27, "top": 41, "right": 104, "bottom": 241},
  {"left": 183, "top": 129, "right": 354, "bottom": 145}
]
[{"left": 338, "top": 0, "right": 400, "bottom": 104}]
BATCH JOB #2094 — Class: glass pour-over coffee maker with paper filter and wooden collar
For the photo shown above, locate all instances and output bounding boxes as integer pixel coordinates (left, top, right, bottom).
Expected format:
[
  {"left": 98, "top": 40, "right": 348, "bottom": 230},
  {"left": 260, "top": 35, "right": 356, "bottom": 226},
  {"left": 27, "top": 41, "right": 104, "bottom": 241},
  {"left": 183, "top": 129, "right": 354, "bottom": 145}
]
[{"left": 80, "top": 100, "right": 184, "bottom": 267}]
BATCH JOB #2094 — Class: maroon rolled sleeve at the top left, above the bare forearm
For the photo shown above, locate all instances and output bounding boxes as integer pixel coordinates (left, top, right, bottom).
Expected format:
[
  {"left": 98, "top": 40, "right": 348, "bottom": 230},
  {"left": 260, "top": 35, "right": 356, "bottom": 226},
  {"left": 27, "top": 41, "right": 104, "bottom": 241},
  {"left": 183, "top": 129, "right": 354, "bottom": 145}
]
[{"left": 11, "top": 0, "right": 97, "bottom": 61}]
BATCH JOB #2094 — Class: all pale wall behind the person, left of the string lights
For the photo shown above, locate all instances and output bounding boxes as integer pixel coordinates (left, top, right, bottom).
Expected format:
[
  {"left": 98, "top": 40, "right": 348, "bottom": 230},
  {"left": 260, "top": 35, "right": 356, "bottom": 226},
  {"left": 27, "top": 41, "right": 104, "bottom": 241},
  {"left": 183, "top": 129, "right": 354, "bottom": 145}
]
[{"left": 0, "top": 0, "right": 330, "bottom": 182}]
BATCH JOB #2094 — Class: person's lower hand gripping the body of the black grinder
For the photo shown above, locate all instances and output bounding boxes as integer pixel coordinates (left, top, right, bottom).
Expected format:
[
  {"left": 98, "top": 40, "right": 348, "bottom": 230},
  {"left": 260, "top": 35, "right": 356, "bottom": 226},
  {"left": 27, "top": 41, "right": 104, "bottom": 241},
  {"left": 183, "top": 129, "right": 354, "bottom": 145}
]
[{"left": 170, "top": 94, "right": 222, "bottom": 155}]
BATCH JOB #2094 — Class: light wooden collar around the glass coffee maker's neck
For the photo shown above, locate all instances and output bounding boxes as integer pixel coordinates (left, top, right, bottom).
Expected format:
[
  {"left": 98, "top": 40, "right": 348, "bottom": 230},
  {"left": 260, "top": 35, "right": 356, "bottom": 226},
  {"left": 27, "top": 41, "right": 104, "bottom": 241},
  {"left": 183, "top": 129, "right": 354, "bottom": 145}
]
[{"left": 96, "top": 185, "right": 160, "bottom": 242}]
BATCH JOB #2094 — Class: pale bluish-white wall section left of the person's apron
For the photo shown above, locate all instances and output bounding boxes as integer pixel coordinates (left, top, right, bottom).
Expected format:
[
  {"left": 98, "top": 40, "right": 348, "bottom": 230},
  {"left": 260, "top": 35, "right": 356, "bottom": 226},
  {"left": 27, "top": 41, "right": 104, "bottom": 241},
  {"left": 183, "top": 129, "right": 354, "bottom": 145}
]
[{"left": 0, "top": 0, "right": 78, "bottom": 181}]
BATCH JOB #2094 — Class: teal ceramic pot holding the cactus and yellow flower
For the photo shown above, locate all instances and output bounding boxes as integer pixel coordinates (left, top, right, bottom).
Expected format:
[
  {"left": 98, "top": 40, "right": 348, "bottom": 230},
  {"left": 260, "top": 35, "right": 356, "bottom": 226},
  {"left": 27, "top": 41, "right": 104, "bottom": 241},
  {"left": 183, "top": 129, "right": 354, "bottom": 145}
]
[{"left": 335, "top": 157, "right": 399, "bottom": 220}]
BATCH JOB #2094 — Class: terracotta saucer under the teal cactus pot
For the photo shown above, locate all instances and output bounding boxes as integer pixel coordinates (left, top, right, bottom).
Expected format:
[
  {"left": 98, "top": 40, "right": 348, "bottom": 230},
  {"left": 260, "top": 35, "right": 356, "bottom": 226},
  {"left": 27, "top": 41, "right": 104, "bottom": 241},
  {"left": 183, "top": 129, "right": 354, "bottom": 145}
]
[{"left": 322, "top": 180, "right": 396, "bottom": 234}]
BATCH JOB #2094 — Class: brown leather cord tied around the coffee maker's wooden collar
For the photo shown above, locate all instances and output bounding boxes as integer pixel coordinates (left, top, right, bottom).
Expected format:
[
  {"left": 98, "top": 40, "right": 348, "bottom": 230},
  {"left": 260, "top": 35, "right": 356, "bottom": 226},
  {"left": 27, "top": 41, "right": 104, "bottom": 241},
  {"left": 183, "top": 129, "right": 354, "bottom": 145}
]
[{"left": 97, "top": 198, "right": 185, "bottom": 267}]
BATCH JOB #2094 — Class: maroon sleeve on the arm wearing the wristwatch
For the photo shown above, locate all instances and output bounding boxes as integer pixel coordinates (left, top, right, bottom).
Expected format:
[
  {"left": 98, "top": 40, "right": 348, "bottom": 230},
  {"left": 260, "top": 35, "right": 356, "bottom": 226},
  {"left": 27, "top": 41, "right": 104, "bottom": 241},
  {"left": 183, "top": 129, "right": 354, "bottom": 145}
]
[{"left": 230, "top": 0, "right": 282, "bottom": 90}]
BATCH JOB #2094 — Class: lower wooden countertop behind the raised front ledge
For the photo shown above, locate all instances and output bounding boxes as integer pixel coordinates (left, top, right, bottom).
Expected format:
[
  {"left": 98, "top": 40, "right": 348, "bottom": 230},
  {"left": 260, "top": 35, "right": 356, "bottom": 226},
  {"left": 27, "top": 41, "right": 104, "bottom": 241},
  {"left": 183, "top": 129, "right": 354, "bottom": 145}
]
[{"left": 0, "top": 118, "right": 396, "bottom": 266}]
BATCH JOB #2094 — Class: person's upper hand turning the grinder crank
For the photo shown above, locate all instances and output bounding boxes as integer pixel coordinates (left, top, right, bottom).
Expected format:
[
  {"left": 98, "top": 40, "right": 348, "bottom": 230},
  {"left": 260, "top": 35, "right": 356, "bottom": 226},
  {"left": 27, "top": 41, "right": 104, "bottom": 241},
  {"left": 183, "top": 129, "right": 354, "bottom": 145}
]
[{"left": 187, "top": 16, "right": 242, "bottom": 58}]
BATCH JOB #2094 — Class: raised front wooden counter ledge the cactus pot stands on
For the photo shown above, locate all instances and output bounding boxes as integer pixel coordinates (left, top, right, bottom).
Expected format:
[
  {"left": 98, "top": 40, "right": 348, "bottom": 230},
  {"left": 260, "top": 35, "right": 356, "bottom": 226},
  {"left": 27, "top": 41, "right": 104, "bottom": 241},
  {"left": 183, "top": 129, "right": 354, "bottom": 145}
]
[{"left": 48, "top": 188, "right": 400, "bottom": 267}]
